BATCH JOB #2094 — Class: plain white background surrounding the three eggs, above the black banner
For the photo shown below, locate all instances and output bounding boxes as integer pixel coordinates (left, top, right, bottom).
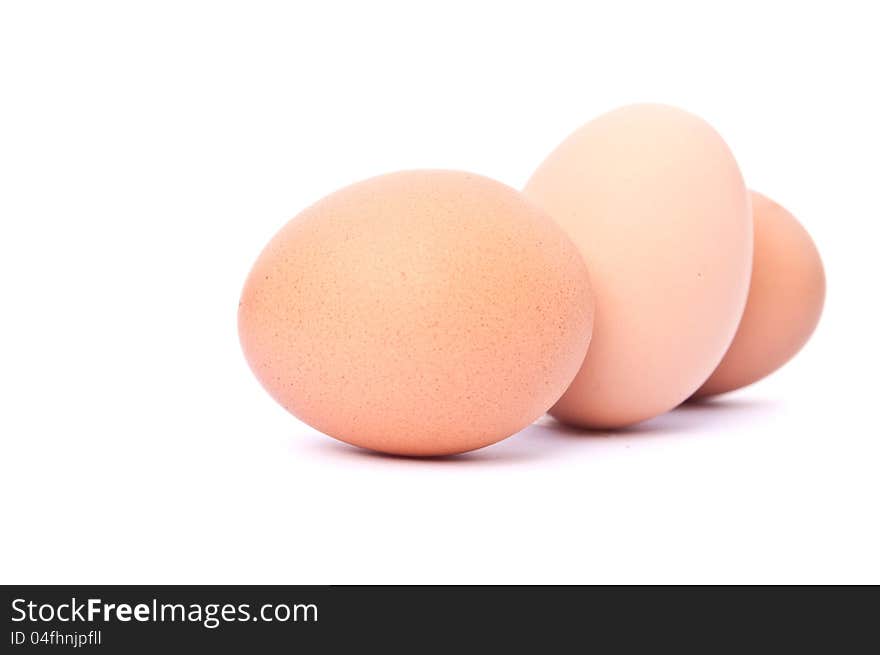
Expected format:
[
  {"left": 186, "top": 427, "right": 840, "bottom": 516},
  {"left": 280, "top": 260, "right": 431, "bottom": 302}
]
[{"left": 0, "top": 0, "right": 880, "bottom": 583}]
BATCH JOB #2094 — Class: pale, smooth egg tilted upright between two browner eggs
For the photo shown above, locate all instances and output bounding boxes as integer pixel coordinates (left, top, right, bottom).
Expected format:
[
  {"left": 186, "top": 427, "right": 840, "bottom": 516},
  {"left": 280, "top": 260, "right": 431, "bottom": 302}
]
[{"left": 525, "top": 105, "right": 752, "bottom": 428}]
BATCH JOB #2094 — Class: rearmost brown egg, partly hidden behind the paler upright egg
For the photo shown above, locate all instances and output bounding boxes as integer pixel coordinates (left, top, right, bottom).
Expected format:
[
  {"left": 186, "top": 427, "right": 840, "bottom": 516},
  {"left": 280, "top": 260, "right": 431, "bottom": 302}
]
[{"left": 695, "top": 191, "right": 825, "bottom": 397}]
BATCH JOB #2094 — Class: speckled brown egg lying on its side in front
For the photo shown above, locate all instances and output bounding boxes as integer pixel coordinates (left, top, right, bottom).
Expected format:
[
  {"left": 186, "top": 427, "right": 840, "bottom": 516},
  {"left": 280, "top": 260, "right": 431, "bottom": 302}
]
[{"left": 239, "top": 171, "right": 593, "bottom": 455}]
